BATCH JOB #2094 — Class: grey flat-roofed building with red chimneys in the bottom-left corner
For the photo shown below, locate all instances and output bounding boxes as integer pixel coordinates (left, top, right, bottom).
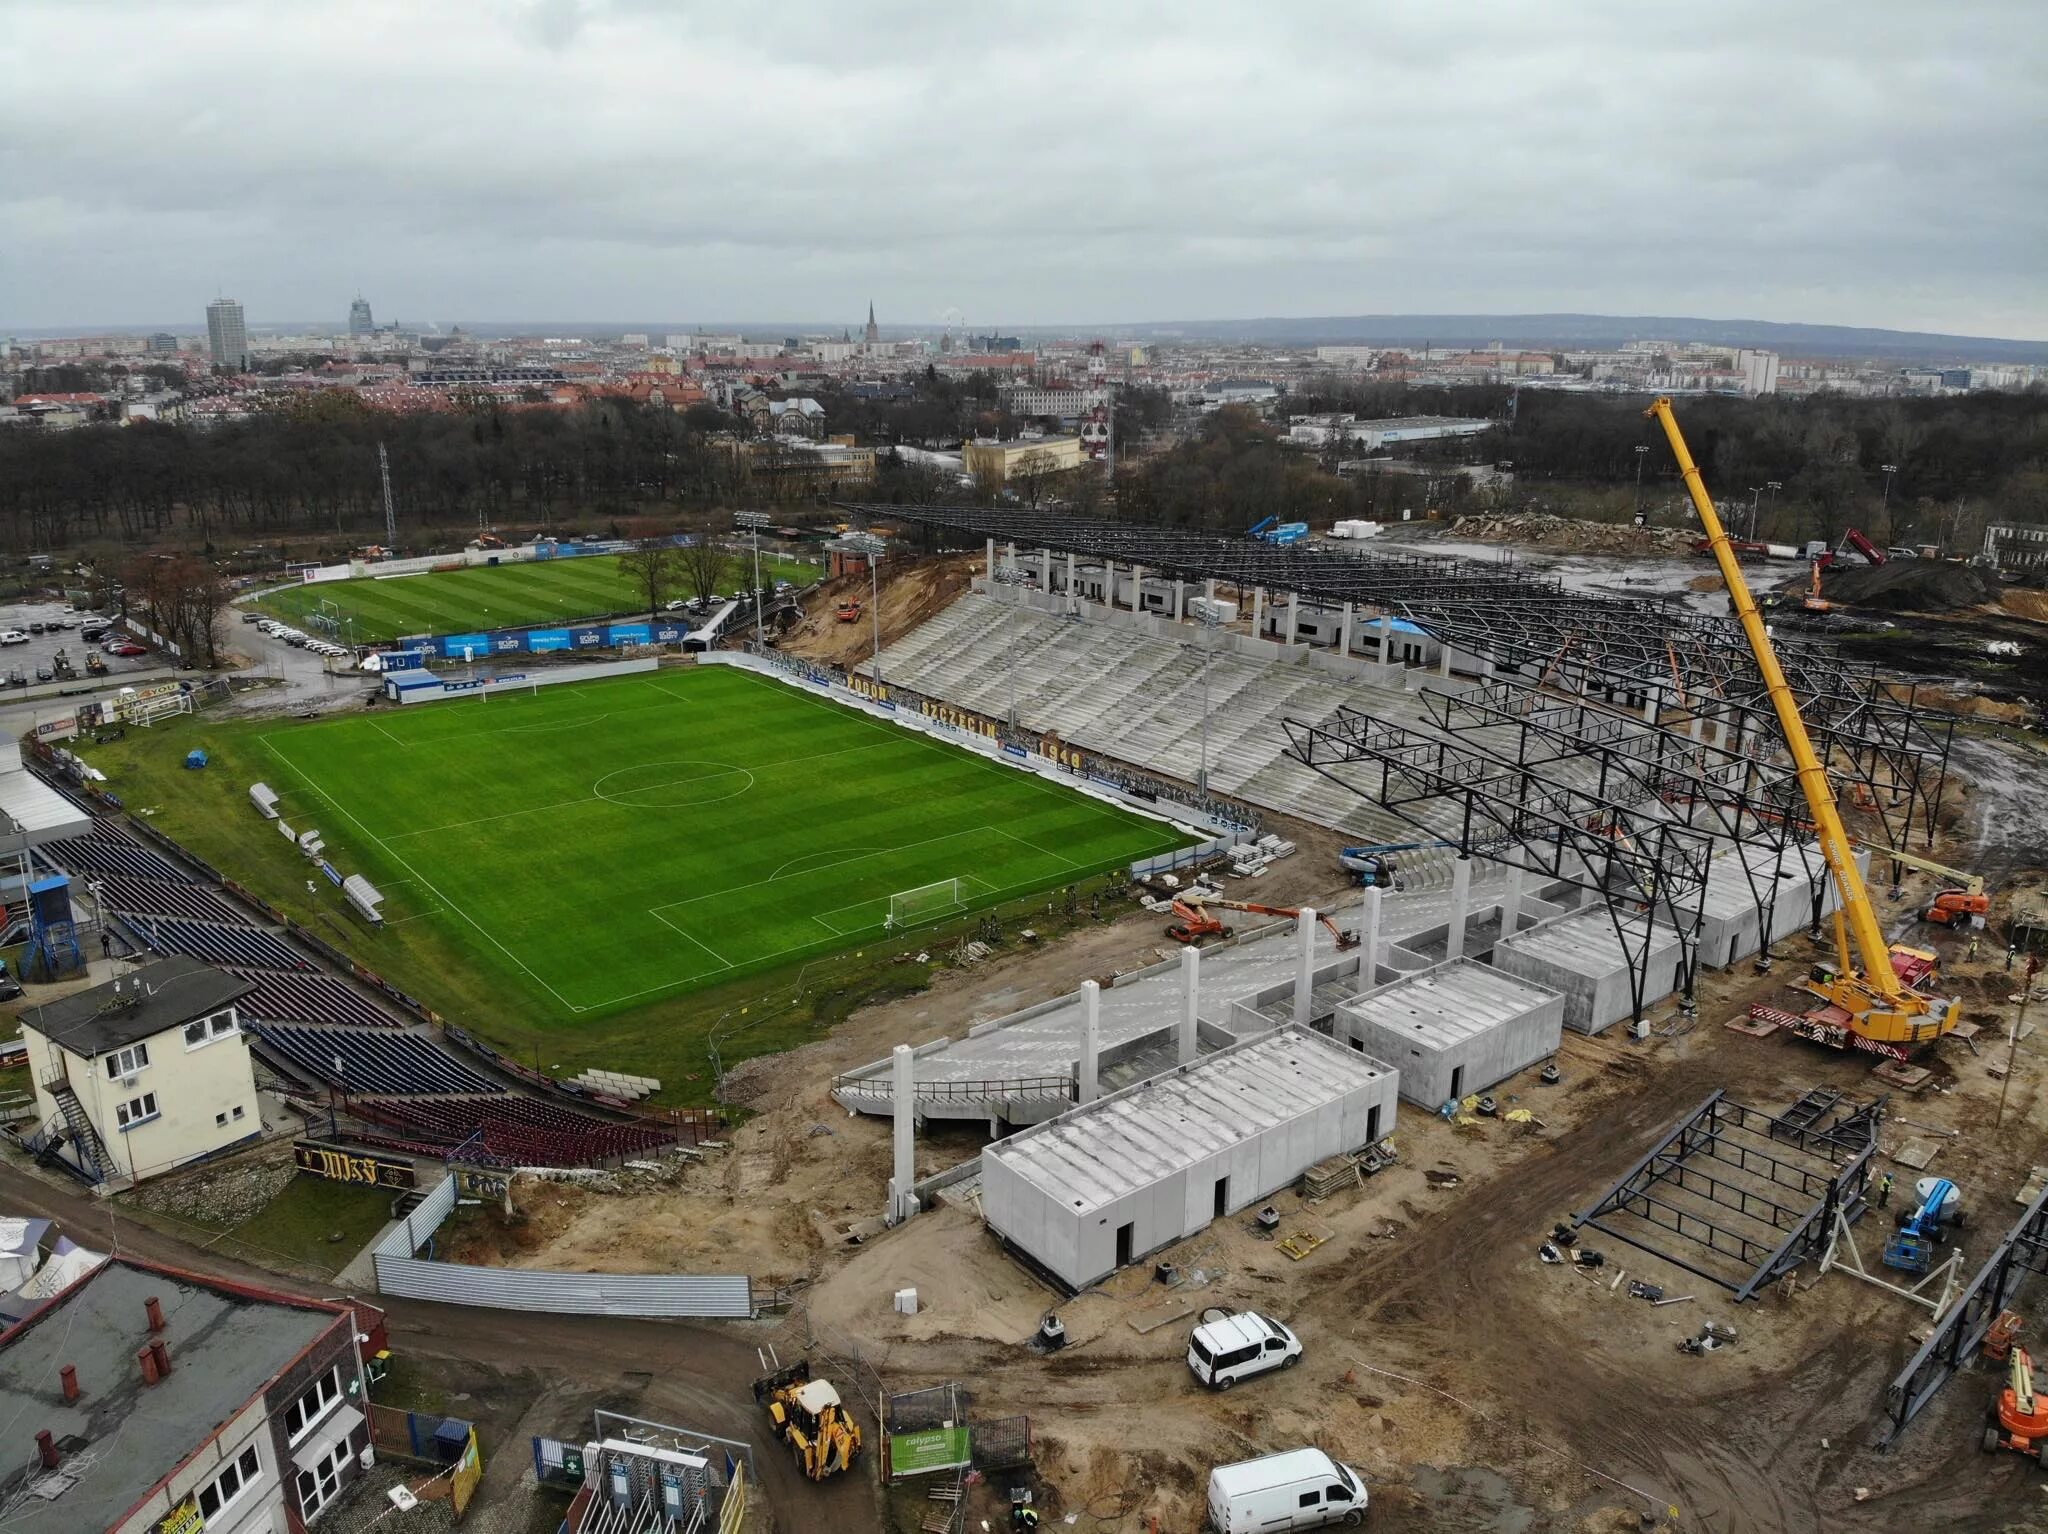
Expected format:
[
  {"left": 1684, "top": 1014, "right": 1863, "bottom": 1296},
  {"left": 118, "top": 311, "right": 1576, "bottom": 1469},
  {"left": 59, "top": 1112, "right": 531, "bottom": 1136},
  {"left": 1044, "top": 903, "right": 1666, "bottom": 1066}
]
[{"left": 0, "top": 1258, "right": 381, "bottom": 1534}]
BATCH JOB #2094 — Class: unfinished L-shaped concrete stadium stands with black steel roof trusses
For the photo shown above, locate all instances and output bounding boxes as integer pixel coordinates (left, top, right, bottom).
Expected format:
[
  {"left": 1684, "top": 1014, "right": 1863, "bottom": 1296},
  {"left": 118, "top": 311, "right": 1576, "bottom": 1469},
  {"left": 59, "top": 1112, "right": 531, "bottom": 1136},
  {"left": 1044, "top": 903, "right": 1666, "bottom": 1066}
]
[{"left": 836, "top": 506, "right": 1956, "bottom": 1122}]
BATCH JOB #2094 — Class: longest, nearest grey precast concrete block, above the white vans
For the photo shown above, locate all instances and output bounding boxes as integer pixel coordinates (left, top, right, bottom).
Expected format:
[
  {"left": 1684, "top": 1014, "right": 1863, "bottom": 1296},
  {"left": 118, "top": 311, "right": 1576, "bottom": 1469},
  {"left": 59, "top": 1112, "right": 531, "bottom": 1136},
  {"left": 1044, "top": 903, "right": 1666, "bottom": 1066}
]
[{"left": 981, "top": 1024, "right": 1399, "bottom": 1290}]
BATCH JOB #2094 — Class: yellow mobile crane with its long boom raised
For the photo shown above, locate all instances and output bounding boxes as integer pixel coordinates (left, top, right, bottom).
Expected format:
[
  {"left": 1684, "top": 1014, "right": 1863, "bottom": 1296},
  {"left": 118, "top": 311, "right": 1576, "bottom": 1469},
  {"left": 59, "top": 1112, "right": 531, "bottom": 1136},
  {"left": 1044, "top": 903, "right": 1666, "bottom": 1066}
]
[{"left": 1642, "top": 397, "right": 1958, "bottom": 1055}]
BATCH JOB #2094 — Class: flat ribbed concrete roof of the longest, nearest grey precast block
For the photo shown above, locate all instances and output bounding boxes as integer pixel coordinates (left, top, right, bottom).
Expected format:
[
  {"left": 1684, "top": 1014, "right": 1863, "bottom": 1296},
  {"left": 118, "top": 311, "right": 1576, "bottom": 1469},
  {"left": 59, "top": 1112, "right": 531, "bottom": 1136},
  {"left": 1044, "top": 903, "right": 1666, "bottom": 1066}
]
[{"left": 983, "top": 1026, "right": 1389, "bottom": 1212}]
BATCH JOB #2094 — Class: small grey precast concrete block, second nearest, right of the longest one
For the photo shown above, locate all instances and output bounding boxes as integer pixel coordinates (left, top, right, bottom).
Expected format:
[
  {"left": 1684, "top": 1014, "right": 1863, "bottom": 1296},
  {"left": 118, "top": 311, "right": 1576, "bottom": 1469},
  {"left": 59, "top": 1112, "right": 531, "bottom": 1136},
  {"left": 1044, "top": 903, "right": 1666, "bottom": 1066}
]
[{"left": 1333, "top": 958, "right": 1565, "bottom": 1112}]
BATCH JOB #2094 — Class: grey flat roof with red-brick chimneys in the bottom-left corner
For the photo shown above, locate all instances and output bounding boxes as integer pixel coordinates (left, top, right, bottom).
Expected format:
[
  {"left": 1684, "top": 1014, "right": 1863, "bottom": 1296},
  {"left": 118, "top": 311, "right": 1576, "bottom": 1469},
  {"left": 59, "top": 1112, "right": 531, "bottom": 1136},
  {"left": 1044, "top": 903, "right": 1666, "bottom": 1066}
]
[{"left": 0, "top": 1258, "right": 354, "bottom": 1534}]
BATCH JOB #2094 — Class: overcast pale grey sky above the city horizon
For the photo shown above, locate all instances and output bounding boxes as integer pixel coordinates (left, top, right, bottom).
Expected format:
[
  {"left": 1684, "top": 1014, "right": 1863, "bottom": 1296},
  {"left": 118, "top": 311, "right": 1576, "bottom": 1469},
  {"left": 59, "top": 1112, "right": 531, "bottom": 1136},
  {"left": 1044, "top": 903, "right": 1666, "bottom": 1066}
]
[{"left": 0, "top": 0, "right": 2048, "bottom": 338}]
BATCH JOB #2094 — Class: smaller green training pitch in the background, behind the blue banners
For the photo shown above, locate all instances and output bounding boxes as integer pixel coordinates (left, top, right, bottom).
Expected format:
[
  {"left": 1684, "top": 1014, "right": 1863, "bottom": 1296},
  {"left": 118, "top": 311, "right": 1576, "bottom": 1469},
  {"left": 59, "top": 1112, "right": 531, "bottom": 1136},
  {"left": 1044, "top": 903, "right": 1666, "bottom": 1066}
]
[{"left": 254, "top": 553, "right": 821, "bottom": 643}]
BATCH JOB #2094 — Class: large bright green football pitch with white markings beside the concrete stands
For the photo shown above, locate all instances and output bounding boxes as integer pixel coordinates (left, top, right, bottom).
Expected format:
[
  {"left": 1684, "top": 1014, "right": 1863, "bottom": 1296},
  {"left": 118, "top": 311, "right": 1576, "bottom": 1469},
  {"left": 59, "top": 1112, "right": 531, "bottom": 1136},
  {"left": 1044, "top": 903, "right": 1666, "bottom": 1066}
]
[{"left": 260, "top": 666, "right": 1188, "bottom": 1016}]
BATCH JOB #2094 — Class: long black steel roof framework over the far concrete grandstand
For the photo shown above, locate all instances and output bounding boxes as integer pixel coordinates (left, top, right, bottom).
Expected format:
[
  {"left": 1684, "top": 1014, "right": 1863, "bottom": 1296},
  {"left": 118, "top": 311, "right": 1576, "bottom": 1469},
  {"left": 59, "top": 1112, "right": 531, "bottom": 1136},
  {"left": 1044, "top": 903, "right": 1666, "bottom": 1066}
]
[{"left": 846, "top": 502, "right": 1956, "bottom": 846}]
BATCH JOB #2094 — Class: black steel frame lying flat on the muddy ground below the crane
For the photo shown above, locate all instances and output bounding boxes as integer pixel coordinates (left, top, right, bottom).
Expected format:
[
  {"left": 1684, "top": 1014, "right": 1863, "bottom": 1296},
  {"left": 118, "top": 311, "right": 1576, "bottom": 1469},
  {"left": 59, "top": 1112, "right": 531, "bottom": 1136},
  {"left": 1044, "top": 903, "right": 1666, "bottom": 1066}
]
[{"left": 1571, "top": 1092, "right": 1884, "bottom": 1303}]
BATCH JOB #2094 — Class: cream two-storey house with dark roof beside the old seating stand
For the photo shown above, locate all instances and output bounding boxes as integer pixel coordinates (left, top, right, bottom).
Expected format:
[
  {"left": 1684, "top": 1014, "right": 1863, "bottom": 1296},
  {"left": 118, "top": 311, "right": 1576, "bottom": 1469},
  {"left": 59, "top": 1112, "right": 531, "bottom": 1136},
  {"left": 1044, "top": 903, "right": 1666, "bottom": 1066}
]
[{"left": 20, "top": 956, "right": 262, "bottom": 1182}]
